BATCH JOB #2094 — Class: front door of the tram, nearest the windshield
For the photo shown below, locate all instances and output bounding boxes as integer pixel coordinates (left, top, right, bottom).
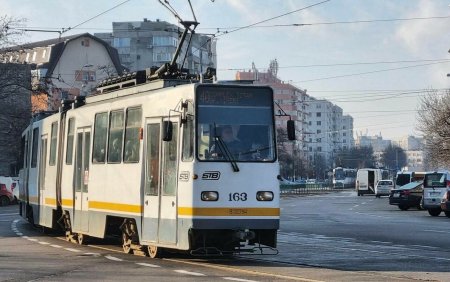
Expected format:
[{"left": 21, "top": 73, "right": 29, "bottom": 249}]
[{"left": 142, "top": 119, "right": 178, "bottom": 244}]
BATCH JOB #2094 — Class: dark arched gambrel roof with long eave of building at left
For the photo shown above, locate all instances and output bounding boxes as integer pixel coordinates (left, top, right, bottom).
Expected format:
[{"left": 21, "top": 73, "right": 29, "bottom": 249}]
[{"left": 0, "top": 33, "right": 123, "bottom": 75}]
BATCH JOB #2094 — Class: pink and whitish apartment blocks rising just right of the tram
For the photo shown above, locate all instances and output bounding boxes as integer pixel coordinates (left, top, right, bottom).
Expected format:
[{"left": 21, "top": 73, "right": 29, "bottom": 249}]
[{"left": 236, "top": 67, "right": 355, "bottom": 167}]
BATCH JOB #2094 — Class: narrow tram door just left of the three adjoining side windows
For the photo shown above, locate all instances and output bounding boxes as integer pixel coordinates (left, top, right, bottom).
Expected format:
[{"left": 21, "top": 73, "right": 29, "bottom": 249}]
[{"left": 73, "top": 128, "right": 91, "bottom": 232}]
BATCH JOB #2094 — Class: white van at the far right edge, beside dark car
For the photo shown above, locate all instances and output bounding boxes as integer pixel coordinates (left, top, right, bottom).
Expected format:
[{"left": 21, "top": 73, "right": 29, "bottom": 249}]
[{"left": 422, "top": 171, "right": 450, "bottom": 216}]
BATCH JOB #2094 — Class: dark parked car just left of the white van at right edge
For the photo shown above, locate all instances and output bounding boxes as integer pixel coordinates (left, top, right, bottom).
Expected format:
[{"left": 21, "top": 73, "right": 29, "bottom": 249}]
[{"left": 389, "top": 181, "right": 423, "bottom": 211}]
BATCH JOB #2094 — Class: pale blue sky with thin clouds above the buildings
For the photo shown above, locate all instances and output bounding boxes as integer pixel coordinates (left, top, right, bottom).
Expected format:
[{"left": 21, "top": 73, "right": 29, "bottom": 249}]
[{"left": 0, "top": 0, "right": 450, "bottom": 140}]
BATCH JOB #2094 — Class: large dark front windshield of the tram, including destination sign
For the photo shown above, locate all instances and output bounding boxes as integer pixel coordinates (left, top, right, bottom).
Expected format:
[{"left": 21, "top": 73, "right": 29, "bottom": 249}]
[{"left": 196, "top": 85, "right": 276, "bottom": 162}]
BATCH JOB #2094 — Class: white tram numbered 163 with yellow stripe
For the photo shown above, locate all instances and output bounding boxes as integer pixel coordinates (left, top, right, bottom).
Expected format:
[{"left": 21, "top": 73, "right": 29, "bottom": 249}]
[{"left": 21, "top": 71, "right": 292, "bottom": 257}]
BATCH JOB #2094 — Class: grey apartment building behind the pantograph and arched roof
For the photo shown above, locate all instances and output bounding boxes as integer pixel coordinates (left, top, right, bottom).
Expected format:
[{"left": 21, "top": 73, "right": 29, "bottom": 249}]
[{"left": 94, "top": 18, "right": 217, "bottom": 74}]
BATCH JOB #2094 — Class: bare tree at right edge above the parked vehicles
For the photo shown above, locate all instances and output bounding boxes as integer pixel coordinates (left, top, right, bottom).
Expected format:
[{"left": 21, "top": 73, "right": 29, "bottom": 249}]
[{"left": 417, "top": 89, "right": 450, "bottom": 169}]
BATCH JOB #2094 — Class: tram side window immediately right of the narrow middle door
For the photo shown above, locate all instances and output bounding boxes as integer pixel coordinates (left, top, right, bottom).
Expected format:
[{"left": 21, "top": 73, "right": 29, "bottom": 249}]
[{"left": 92, "top": 113, "right": 108, "bottom": 164}]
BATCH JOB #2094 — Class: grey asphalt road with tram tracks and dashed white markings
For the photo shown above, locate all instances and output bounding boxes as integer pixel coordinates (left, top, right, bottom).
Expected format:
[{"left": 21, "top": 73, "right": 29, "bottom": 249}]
[{"left": 0, "top": 191, "right": 450, "bottom": 281}]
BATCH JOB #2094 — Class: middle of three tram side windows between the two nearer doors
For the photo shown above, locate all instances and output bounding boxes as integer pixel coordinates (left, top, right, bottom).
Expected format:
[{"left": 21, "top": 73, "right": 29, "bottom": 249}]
[{"left": 108, "top": 110, "right": 124, "bottom": 163}]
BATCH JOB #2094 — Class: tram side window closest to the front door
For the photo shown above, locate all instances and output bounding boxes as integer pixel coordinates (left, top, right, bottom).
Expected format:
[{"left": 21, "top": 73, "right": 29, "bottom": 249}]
[{"left": 123, "top": 108, "right": 142, "bottom": 163}]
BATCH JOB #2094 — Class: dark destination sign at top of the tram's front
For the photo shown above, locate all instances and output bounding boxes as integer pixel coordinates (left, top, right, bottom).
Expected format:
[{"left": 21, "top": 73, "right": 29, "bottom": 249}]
[{"left": 197, "top": 85, "right": 273, "bottom": 107}]
